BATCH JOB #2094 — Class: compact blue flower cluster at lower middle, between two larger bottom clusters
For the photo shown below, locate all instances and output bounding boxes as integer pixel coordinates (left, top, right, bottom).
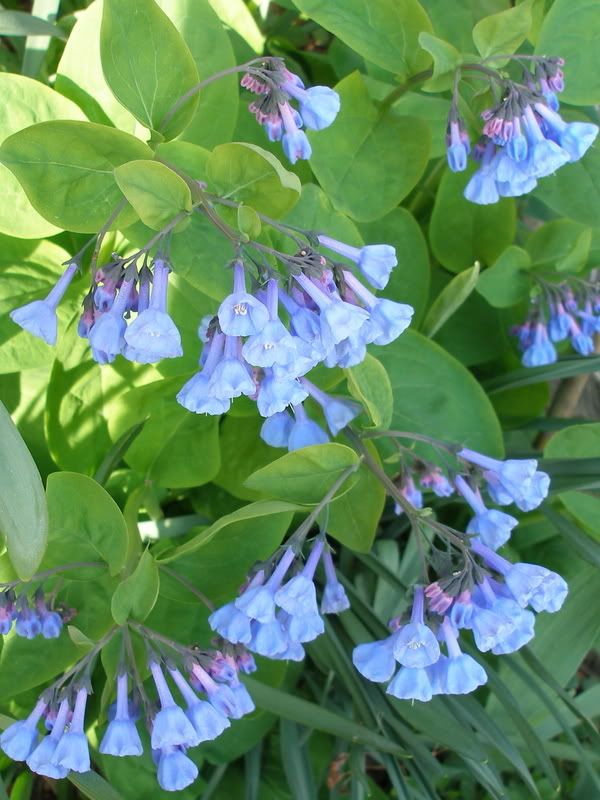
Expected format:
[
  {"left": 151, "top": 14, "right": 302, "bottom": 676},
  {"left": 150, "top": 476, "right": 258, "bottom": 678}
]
[{"left": 208, "top": 536, "right": 350, "bottom": 661}]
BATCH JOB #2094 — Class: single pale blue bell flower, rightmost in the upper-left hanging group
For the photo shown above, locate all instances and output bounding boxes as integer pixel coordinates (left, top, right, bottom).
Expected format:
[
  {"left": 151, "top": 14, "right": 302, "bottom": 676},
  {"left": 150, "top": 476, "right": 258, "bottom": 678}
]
[{"left": 124, "top": 257, "right": 183, "bottom": 364}]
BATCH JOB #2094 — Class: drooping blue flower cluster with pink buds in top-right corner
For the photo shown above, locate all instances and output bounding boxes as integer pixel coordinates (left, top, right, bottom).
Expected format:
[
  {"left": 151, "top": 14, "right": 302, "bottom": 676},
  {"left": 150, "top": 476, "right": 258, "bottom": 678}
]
[{"left": 447, "top": 57, "right": 598, "bottom": 205}]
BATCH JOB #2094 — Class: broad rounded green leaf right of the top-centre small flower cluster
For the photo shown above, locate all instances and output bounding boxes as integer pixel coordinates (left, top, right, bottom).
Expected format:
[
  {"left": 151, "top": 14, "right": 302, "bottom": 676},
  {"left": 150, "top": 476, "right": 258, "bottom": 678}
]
[{"left": 309, "top": 72, "right": 431, "bottom": 222}]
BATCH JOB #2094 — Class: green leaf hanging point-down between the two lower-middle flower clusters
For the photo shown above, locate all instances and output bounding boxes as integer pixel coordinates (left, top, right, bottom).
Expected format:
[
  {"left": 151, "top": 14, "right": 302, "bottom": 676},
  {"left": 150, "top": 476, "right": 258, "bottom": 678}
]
[{"left": 327, "top": 442, "right": 386, "bottom": 553}]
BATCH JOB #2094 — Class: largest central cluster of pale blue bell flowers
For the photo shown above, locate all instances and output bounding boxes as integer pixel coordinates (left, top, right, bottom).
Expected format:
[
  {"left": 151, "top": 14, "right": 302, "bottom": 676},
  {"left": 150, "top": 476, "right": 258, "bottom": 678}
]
[{"left": 177, "top": 252, "right": 413, "bottom": 422}]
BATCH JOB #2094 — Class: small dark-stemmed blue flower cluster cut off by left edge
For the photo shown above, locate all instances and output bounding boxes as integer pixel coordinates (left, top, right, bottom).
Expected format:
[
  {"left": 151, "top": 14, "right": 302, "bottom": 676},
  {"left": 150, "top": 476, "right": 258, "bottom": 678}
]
[{"left": 0, "top": 589, "right": 70, "bottom": 639}]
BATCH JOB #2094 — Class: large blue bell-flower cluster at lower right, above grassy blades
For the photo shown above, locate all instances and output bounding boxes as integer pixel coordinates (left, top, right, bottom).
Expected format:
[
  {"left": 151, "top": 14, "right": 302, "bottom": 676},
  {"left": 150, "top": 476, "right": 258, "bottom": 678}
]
[{"left": 353, "top": 449, "right": 567, "bottom": 701}]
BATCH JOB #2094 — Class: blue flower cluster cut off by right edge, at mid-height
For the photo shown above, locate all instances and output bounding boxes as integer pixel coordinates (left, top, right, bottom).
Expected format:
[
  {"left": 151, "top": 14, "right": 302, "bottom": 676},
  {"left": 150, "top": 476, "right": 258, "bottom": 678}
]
[{"left": 513, "top": 279, "right": 600, "bottom": 367}]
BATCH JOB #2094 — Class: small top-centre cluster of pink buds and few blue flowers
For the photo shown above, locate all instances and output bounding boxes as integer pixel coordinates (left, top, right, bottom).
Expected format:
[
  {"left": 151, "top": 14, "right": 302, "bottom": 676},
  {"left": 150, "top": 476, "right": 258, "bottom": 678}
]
[{"left": 241, "top": 58, "right": 340, "bottom": 164}]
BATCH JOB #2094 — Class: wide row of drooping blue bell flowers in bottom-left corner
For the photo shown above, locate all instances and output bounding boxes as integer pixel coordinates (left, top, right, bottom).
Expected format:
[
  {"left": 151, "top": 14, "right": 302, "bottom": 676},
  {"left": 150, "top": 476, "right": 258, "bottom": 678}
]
[{"left": 0, "top": 645, "right": 256, "bottom": 791}]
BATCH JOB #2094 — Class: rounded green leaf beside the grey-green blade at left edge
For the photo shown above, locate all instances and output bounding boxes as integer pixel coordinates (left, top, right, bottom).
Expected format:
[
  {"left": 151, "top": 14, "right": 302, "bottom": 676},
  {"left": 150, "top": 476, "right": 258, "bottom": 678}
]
[{"left": 44, "top": 472, "right": 128, "bottom": 575}]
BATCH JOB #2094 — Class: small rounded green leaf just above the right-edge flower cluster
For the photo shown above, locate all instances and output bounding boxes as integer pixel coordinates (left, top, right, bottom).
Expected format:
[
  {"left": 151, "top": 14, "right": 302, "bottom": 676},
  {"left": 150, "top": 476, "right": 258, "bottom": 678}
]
[{"left": 525, "top": 219, "right": 592, "bottom": 272}]
